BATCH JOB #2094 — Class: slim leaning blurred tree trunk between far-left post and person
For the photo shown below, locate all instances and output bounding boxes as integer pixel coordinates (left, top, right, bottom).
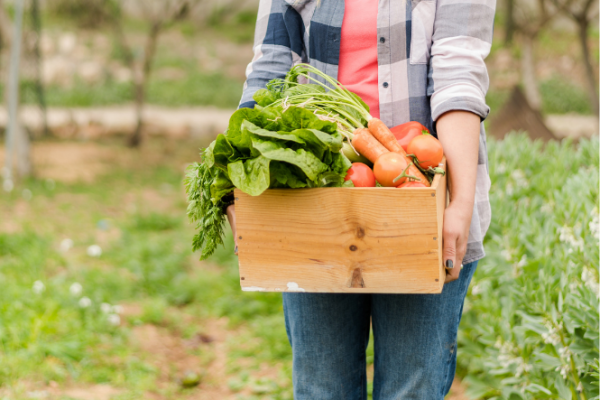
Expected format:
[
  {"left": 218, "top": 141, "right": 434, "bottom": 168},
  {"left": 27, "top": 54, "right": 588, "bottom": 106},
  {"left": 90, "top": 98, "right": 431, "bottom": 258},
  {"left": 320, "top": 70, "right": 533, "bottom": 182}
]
[{"left": 129, "top": 22, "right": 162, "bottom": 147}]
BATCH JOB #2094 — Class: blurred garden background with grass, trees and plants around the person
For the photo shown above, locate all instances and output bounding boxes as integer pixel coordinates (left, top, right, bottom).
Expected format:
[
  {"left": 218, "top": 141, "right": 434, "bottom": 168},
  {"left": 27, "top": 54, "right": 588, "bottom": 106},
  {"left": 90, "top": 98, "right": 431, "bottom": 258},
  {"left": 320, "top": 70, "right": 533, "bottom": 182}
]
[{"left": 0, "top": 0, "right": 599, "bottom": 400}]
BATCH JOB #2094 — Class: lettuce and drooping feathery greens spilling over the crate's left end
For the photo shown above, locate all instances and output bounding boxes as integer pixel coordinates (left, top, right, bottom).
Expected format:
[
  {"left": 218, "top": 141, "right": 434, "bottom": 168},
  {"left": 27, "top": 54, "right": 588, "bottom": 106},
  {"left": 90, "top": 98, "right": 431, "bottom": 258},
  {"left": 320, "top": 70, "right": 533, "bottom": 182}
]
[{"left": 186, "top": 104, "right": 352, "bottom": 259}]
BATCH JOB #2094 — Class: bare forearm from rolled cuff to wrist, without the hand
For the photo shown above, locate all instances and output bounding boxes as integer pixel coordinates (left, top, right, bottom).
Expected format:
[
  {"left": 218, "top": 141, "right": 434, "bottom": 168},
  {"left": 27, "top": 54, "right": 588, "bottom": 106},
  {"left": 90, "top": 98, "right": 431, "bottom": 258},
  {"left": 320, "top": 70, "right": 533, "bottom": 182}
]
[{"left": 437, "top": 111, "right": 481, "bottom": 210}]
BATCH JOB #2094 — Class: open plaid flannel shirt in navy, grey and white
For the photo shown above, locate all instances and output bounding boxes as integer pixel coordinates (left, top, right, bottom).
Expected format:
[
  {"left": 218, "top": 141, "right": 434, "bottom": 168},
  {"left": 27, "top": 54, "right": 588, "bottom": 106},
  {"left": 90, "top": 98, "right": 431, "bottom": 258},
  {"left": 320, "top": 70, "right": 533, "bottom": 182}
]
[{"left": 240, "top": 0, "right": 495, "bottom": 264}]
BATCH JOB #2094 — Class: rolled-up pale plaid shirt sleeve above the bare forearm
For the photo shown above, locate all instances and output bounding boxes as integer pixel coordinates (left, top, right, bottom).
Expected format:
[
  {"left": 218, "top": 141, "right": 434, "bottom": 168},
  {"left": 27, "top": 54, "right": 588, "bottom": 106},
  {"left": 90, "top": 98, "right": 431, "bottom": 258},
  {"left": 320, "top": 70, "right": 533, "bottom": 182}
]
[{"left": 428, "top": 0, "right": 496, "bottom": 121}]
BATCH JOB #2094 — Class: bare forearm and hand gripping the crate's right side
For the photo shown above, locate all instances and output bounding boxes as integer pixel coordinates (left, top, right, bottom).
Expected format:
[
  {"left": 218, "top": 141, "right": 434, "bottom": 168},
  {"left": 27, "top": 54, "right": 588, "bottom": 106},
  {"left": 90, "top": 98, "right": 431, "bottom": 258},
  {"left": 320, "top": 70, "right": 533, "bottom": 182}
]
[{"left": 437, "top": 111, "right": 481, "bottom": 283}]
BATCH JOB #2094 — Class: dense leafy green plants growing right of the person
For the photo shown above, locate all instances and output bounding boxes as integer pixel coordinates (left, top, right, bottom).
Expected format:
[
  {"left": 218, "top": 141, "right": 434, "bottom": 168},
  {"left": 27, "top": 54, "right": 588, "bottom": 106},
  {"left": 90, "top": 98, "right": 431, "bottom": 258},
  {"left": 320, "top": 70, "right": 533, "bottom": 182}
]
[{"left": 458, "top": 134, "right": 599, "bottom": 400}]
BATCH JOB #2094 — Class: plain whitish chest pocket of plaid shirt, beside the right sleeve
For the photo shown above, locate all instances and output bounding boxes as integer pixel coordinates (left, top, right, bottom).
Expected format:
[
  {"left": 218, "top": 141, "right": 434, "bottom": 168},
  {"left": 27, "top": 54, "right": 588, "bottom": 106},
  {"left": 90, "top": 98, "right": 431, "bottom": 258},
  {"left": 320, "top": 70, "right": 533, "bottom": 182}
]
[{"left": 410, "top": 0, "right": 436, "bottom": 64}]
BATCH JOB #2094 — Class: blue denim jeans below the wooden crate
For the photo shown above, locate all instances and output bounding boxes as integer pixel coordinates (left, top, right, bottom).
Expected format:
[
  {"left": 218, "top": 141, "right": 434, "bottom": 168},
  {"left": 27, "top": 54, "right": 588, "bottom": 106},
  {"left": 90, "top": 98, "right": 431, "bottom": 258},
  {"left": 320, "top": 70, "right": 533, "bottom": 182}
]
[{"left": 283, "top": 261, "right": 477, "bottom": 400}]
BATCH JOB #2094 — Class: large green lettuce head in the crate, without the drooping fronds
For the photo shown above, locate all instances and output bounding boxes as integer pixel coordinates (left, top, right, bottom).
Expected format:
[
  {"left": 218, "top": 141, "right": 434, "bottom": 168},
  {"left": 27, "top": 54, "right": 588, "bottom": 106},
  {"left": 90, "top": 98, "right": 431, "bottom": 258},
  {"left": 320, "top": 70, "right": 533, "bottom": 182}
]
[{"left": 203, "top": 106, "right": 351, "bottom": 198}]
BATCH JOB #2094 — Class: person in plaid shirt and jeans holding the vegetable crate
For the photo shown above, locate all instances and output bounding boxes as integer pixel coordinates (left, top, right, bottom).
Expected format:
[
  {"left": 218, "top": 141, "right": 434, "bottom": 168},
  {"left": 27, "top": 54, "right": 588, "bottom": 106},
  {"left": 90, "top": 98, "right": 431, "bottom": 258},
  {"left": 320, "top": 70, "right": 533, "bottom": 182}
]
[{"left": 228, "top": 0, "right": 495, "bottom": 400}]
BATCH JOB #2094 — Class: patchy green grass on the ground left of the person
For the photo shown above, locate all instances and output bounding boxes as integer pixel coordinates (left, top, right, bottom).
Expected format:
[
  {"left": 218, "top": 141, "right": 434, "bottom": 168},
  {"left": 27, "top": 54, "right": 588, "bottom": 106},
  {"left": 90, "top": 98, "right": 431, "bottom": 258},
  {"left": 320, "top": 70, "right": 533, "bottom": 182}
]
[{"left": 0, "top": 140, "right": 291, "bottom": 399}]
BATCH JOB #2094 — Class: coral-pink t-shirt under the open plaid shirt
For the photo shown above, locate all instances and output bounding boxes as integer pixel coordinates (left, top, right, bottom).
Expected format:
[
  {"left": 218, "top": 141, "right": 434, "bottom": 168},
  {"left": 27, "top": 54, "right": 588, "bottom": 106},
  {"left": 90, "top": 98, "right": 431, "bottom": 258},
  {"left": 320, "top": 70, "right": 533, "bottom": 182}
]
[{"left": 338, "top": 0, "right": 379, "bottom": 118}]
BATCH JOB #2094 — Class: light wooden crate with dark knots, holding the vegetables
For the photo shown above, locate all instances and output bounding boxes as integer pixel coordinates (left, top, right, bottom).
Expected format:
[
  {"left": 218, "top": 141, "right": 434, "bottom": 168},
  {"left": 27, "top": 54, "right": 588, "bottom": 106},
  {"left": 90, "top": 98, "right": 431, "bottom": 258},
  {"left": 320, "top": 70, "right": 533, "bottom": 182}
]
[{"left": 235, "top": 163, "right": 446, "bottom": 293}]
